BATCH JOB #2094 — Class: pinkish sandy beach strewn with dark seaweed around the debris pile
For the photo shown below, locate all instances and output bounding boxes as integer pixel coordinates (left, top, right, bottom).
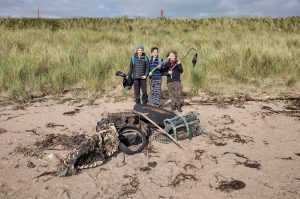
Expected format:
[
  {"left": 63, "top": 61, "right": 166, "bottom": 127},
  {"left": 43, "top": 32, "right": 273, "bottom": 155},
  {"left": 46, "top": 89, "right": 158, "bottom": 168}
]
[{"left": 0, "top": 95, "right": 300, "bottom": 199}]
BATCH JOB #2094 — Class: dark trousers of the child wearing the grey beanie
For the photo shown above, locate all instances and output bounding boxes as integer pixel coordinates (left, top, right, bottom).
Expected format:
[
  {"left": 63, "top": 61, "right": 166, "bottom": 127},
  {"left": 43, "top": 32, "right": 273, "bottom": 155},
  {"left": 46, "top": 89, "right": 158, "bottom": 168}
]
[{"left": 133, "top": 79, "right": 148, "bottom": 104}]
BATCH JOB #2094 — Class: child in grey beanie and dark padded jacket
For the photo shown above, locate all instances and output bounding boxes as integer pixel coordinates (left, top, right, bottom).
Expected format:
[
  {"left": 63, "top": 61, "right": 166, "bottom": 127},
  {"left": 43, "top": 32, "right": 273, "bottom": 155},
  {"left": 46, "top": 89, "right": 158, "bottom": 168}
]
[{"left": 127, "top": 44, "right": 149, "bottom": 104}]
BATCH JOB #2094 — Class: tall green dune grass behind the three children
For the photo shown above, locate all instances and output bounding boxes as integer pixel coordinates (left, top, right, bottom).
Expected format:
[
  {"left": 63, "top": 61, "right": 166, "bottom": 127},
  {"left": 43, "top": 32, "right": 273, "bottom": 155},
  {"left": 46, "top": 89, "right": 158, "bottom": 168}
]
[{"left": 0, "top": 17, "right": 300, "bottom": 100}]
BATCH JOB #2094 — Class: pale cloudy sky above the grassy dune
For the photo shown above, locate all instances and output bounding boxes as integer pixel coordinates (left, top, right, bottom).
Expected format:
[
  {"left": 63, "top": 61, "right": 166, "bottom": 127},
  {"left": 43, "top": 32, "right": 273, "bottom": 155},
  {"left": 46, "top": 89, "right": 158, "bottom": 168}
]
[{"left": 0, "top": 0, "right": 300, "bottom": 18}]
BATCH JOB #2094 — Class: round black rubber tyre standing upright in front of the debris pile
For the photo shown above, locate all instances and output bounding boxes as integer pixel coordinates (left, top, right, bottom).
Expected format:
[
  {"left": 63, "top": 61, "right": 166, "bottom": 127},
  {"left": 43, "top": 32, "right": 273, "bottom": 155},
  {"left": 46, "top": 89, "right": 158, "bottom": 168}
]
[{"left": 118, "top": 126, "right": 148, "bottom": 155}]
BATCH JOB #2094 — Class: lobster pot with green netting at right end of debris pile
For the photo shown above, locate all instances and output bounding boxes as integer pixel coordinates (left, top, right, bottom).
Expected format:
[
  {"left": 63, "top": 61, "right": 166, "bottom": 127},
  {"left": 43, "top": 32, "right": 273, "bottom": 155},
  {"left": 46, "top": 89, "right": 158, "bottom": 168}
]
[{"left": 164, "top": 112, "right": 203, "bottom": 140}]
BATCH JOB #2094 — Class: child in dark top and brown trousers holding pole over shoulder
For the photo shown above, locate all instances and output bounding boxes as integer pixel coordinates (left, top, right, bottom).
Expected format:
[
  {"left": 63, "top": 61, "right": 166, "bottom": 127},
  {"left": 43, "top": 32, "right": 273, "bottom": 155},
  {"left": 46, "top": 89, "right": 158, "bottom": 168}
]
[{"left": 164, "top": 51, "right": 183, "bottom": 112}]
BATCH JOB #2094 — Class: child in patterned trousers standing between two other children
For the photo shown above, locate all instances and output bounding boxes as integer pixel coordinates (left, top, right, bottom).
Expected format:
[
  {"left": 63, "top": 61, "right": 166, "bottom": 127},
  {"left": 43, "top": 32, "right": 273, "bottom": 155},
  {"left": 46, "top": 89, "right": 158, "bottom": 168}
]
[{"left": 149, "top": 47, "right": 164, "bottom": 107}]
